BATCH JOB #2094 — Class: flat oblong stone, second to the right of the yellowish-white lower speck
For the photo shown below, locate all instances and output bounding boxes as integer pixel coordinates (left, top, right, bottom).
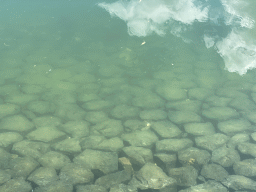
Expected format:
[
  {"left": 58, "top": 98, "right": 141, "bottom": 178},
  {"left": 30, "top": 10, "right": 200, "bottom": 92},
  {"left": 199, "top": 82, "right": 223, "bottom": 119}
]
[{"left": 184, "top": 122, "right": 215, "bottom": 136}]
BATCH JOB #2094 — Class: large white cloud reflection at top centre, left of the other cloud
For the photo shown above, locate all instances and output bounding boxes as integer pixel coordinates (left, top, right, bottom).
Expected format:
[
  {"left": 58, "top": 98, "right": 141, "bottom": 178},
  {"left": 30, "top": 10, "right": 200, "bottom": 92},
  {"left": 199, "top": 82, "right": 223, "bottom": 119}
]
[{"left": 99, "top": 0, "right": 208, "bottom": 37}]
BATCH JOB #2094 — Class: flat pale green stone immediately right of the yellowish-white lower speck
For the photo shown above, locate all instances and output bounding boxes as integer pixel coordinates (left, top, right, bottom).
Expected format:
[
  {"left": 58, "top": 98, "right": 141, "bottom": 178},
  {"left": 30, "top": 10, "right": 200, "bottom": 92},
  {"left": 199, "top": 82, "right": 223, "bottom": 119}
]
[{"left": 151, "top": 121, "right": 182, "bottom": 138}]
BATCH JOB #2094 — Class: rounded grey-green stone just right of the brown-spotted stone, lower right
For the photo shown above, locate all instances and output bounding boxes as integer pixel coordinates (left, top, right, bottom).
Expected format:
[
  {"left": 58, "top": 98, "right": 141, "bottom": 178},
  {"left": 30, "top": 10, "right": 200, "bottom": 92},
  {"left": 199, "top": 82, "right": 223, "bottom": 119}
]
[{"left": 211, "top": 146, "right": 240, "bottom": 167}]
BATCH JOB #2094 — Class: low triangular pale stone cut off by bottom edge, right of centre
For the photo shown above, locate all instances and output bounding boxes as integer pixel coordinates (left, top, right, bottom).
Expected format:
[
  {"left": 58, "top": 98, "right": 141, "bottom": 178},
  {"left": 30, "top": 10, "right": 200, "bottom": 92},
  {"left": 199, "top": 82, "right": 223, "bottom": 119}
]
[{"left": 179, "top": 180, "right": 228, "bottom": 192}]
